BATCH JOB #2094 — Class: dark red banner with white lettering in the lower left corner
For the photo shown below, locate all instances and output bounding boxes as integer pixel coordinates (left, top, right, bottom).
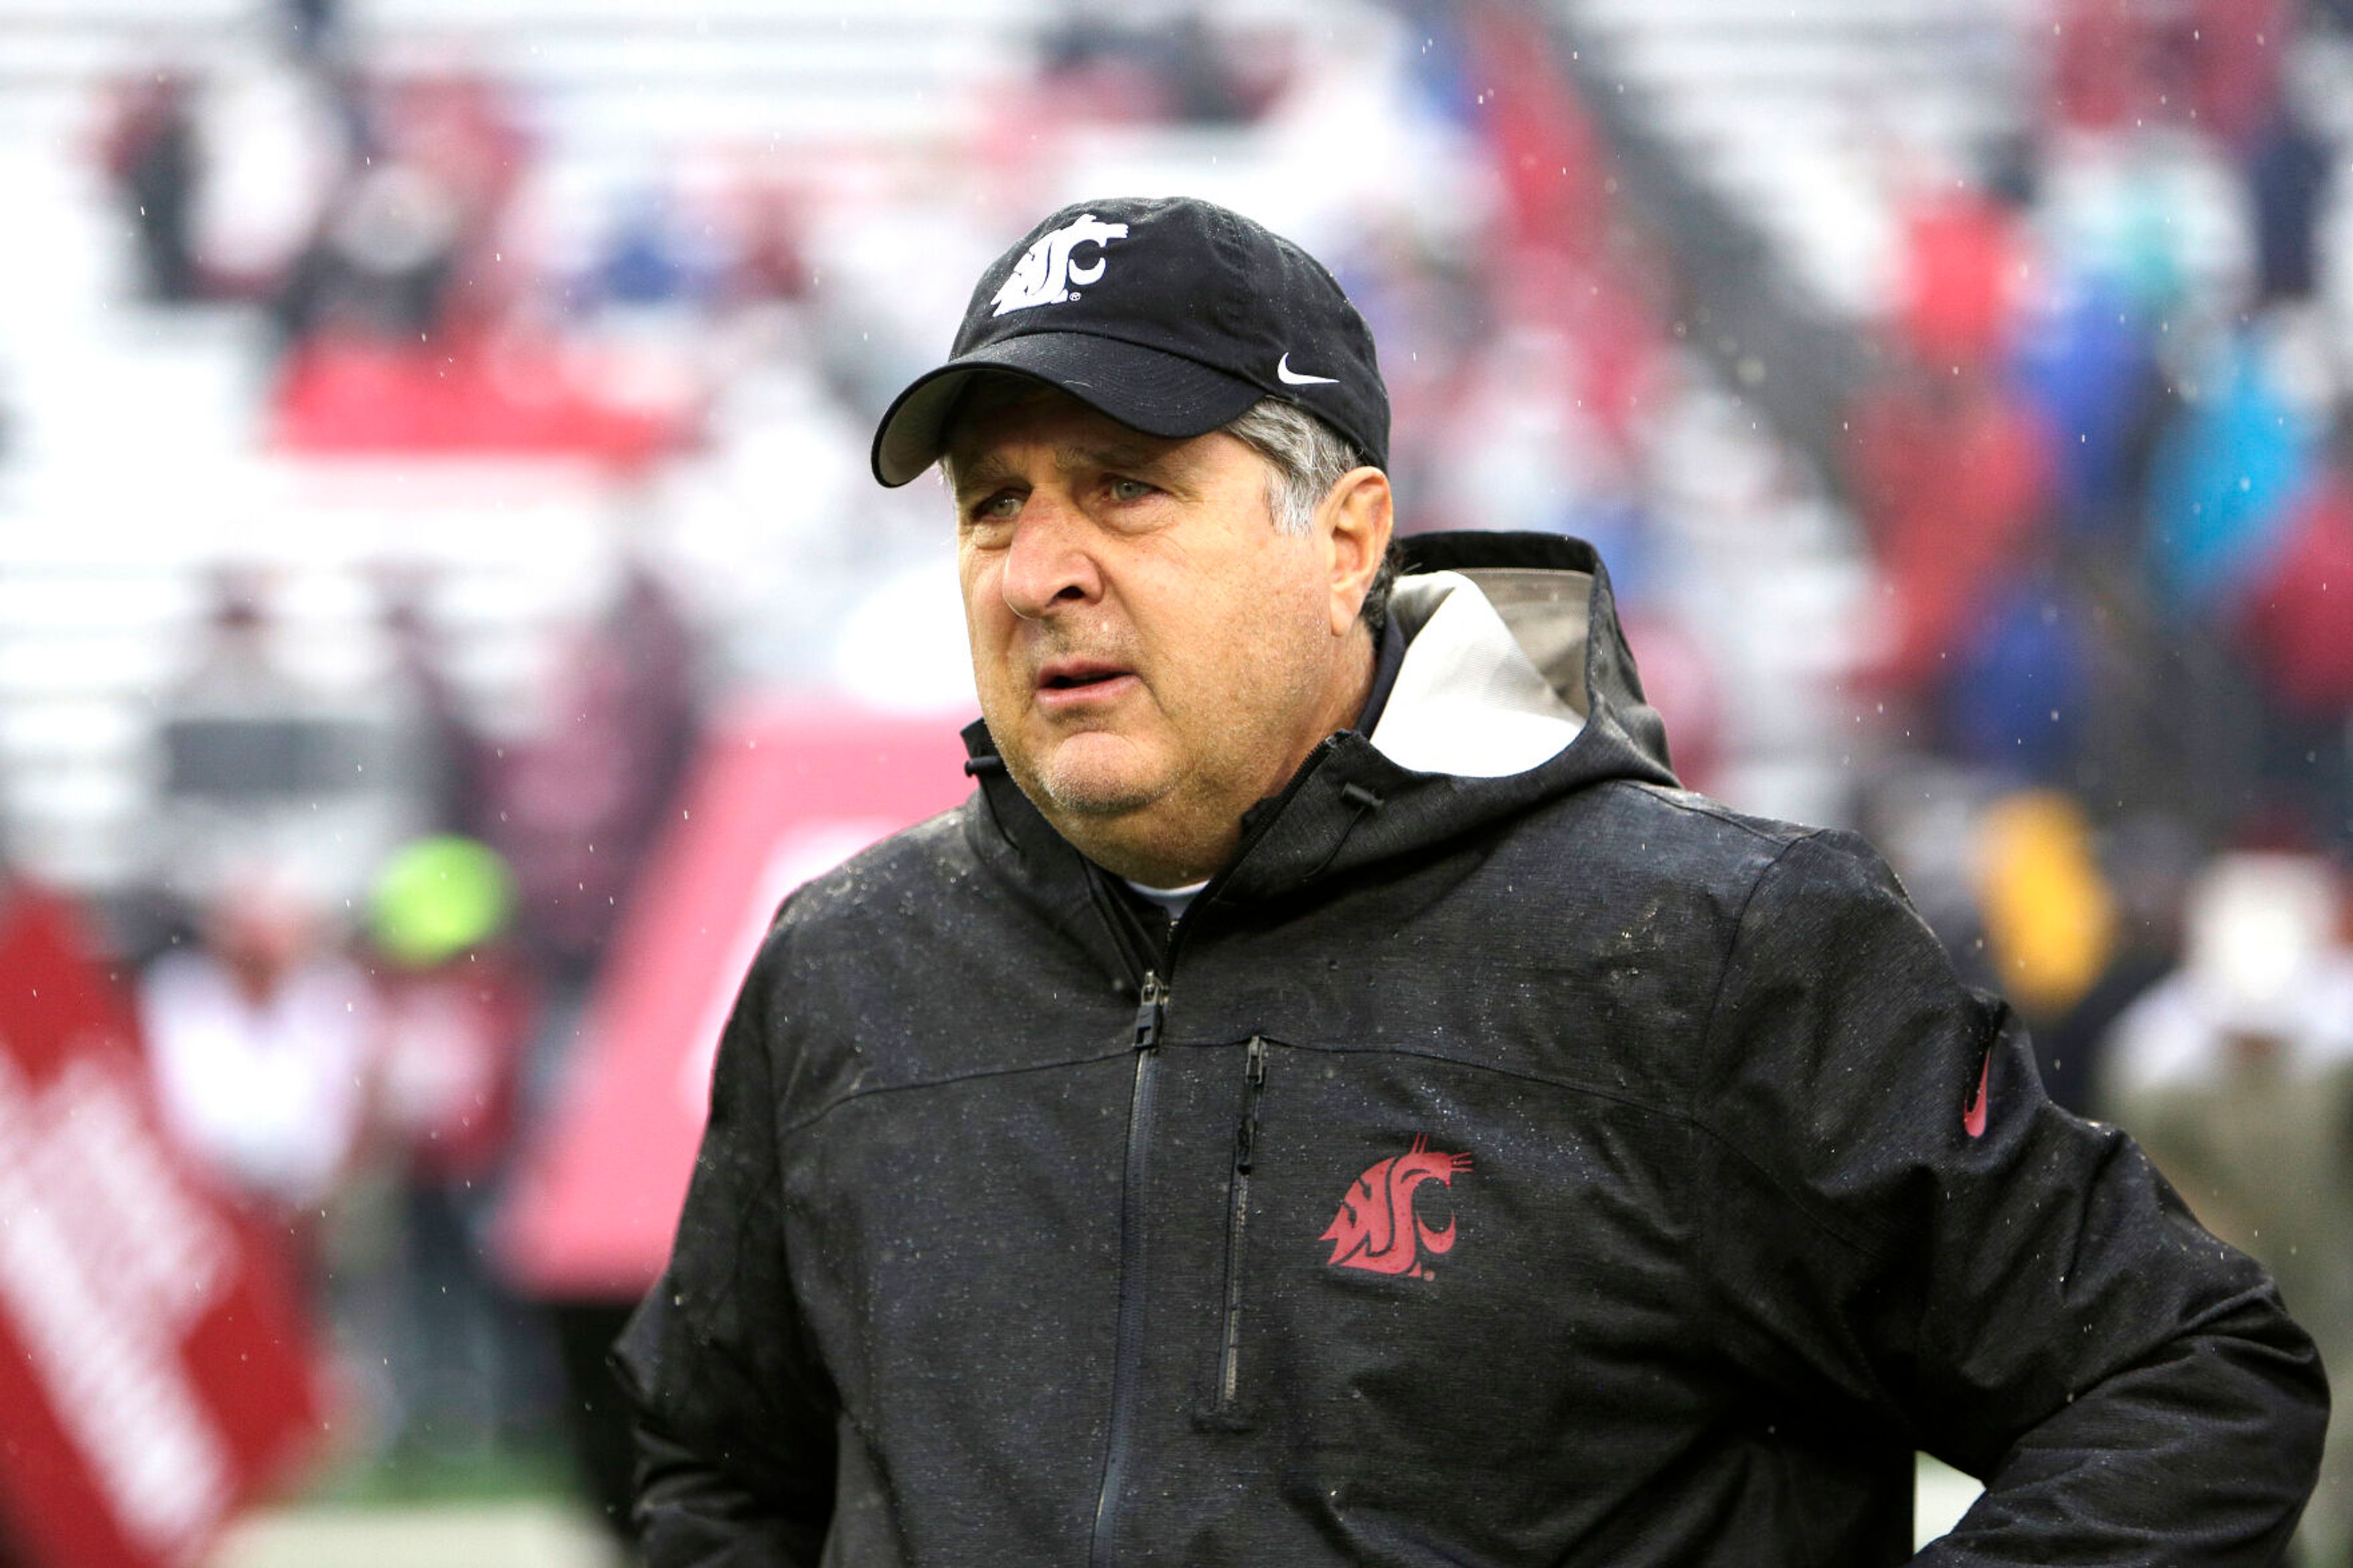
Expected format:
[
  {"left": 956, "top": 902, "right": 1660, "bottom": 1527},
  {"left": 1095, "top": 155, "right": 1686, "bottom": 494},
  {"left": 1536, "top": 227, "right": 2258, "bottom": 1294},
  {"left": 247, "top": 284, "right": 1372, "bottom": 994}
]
[{"left": 0, "top": 885, "right": 322, "bottom": 1568}]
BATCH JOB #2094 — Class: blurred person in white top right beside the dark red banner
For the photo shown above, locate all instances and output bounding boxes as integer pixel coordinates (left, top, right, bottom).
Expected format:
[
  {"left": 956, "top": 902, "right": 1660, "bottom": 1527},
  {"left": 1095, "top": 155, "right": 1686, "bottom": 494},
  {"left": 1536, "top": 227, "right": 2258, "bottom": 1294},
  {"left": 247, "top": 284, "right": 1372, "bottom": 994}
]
[{"left": 139, "top": 869, "right": 374, "bottom": 1283}]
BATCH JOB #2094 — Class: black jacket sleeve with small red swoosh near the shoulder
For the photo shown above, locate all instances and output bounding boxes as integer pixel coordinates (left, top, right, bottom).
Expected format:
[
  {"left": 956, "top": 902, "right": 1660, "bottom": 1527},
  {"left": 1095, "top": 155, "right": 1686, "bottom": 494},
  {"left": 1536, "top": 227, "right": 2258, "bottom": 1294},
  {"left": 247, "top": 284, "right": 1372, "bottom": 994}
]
[{"left": 1694, "top": 833, "right": 2327, "bottom": 1568}]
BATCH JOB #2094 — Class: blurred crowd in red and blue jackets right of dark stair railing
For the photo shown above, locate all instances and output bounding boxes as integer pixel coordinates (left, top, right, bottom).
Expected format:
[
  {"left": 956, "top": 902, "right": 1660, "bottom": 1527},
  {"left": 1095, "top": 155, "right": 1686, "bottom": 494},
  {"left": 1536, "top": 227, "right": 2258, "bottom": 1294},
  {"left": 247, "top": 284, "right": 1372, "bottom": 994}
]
[{"left": 1847, "top": 0, "right": 2353, "bottom": 1563}]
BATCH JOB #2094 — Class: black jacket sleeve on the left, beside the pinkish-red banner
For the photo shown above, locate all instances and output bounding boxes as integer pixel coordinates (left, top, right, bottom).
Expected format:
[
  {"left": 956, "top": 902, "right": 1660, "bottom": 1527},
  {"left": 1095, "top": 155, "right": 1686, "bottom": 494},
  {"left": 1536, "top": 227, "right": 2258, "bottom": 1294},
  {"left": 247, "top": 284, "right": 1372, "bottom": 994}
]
[{"left": 614, "top": 934, "right": 835, "bottom": 1568}]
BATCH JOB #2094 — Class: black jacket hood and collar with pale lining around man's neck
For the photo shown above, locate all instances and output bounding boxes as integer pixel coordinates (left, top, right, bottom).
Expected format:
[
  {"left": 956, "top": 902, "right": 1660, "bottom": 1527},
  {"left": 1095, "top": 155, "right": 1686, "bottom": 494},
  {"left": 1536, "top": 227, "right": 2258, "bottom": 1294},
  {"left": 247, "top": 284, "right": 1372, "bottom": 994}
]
[{"left": 964, "top": 532, "right": 1675, "bottom": 947}]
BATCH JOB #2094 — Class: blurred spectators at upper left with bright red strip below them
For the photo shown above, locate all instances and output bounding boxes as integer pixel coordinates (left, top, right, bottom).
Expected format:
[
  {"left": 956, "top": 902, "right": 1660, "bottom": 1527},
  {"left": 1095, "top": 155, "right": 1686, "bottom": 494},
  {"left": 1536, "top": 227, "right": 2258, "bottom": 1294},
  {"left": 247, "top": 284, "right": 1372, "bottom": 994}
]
[{"left": 104, "top": 27, "right": 696, "bottom": 464}]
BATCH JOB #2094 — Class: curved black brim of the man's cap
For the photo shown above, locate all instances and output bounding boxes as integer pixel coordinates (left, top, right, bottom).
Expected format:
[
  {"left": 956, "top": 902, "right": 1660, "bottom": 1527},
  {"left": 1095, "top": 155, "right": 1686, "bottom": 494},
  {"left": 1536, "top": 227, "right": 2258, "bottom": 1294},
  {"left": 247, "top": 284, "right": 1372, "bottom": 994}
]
[{"left": 873, "top": 332, "right": 1266, "bottom": 485}]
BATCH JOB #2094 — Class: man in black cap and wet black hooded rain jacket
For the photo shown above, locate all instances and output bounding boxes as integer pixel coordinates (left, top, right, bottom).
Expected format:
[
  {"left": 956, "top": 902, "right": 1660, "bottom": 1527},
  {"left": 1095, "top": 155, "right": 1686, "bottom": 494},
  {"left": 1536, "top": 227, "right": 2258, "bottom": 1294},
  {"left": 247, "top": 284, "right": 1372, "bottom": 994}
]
[{"left": 619, "top": 200, "right": 2327, "bottom": 1568}]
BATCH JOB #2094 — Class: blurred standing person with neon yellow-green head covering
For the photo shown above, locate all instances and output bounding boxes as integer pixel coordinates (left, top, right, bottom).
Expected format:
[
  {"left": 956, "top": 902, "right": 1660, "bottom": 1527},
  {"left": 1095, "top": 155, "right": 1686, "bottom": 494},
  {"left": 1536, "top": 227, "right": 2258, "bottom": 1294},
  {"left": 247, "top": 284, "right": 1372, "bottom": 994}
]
[{"left": 369, "top": 836, "right": 544, "bottom": 1450}]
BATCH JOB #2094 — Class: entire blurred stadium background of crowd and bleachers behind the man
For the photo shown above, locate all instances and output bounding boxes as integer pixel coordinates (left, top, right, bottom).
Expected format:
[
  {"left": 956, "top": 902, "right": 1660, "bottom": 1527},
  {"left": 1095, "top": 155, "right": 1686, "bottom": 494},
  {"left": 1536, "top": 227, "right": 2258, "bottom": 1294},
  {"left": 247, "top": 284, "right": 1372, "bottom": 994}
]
[{"left": 0, "top": 0, "right": 2353, "bottom": 1568}]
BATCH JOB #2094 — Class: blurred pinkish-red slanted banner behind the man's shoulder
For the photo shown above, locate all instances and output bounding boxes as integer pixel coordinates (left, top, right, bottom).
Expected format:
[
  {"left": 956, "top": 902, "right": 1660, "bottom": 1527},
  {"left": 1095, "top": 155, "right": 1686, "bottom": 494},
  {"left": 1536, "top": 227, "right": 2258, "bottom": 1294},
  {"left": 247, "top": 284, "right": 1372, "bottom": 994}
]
[{"left": 501, "top": 706, "right": 969, "bottom": 1300}]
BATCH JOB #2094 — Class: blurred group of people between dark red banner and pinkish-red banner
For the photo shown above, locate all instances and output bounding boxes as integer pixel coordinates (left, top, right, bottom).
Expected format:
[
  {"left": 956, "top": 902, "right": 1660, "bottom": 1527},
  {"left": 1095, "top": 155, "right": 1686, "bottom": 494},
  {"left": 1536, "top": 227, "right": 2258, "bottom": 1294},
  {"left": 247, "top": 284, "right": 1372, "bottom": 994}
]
[{"left": 105, "top": 553, "right": 703, "bottom": 1502}]
